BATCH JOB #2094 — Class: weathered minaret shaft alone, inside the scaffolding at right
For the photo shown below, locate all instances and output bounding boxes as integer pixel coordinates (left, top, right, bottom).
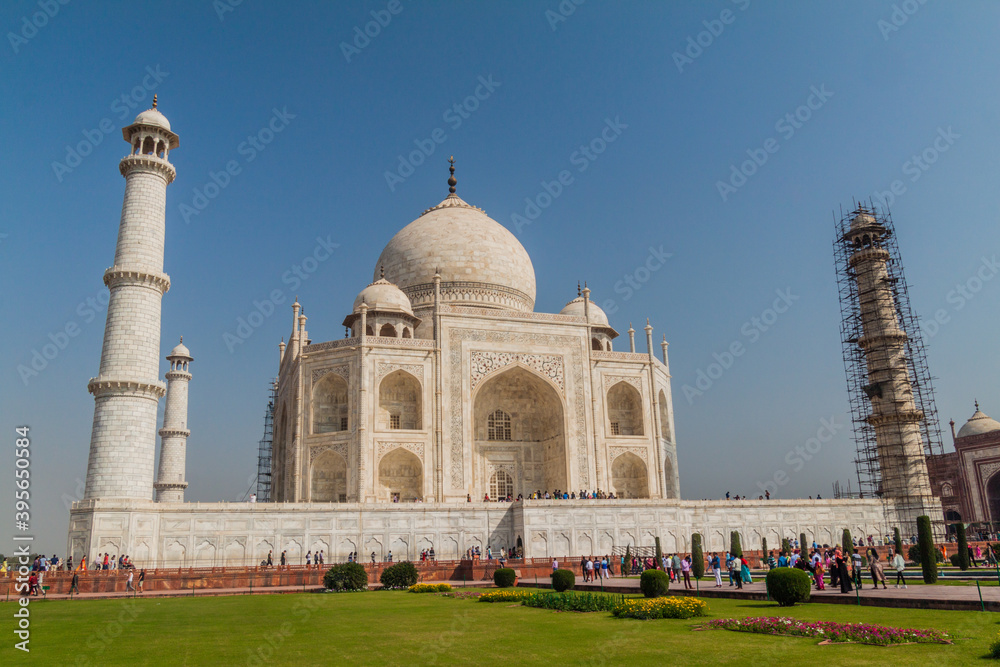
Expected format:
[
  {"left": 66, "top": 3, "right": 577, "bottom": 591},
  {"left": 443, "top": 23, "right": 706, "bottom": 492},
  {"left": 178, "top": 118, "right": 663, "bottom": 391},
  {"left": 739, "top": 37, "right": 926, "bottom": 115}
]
[{"left": 843, "top": 207, "right": 940, "bottom": 521}]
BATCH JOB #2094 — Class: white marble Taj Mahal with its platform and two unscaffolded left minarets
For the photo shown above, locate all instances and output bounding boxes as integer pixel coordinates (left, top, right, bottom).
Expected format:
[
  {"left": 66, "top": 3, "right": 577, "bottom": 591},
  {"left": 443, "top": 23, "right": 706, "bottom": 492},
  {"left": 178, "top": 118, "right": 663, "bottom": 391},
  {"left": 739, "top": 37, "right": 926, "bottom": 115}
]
[{"left": 67, "top": 101, "right": 941, "bottom": 566}]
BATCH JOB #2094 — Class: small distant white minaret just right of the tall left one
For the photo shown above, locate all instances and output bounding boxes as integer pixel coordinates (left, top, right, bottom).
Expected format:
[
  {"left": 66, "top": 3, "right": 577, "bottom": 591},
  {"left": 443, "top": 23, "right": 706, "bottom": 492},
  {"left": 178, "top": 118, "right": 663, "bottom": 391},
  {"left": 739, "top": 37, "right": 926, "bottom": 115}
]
[{"left": 153, "top": 336, "right": 194, "bottom": 503}]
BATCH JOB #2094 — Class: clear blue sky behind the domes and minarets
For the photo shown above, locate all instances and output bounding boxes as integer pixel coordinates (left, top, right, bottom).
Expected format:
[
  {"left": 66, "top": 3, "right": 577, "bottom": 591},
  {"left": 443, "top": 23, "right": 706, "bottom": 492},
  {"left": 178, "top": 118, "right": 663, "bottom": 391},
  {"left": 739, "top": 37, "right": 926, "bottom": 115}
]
[{"left": 0, "top": 0, "right": 1000, "bottom": 554}]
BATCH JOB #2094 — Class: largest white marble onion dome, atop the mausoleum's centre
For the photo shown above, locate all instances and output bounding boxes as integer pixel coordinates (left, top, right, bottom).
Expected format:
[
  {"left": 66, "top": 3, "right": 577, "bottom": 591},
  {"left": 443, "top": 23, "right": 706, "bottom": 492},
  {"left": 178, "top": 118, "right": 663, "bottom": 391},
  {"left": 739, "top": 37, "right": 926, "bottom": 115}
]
[{"left": 375, "top": 194, "right": 535, "bottom": 311}]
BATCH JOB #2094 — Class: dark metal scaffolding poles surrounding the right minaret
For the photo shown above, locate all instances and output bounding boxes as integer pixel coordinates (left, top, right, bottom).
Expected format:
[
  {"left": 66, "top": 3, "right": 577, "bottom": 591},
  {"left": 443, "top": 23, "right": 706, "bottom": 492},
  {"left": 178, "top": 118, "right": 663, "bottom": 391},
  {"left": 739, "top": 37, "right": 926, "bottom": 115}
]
[{"left": 833, "top": 202, "right": 943, "bottom": 525}]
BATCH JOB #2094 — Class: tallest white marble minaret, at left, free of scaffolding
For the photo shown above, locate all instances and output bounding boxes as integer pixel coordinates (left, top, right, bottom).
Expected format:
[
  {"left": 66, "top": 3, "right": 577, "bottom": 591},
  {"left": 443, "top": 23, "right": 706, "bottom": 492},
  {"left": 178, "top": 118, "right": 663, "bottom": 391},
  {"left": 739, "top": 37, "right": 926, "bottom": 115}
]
[{"left": 84, "top": 95, "right": 179, "bottom": 500}]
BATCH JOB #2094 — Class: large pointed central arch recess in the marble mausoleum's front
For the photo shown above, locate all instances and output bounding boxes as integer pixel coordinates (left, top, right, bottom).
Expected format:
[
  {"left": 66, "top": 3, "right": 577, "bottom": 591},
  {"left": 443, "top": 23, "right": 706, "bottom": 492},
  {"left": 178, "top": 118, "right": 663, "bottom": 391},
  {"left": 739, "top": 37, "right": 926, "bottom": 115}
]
[{"left": 473, "top": 366, "right": 569, "bottom": 496}]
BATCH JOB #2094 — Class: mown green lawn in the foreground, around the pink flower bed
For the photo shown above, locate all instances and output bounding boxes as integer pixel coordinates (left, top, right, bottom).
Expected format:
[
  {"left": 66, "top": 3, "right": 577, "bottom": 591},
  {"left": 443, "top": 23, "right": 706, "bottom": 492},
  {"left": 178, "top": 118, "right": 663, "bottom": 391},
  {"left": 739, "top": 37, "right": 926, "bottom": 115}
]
[{"left": 0, "top": 592, "right": 1000, "bottom": 666}]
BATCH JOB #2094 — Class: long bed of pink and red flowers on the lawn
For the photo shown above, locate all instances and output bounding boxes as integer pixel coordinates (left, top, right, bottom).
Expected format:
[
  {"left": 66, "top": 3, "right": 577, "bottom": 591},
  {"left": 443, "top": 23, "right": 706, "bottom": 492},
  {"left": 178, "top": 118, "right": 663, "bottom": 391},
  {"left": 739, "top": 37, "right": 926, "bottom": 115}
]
[{"left": 708, "top": 616, "right": 950, "bottom": 646}]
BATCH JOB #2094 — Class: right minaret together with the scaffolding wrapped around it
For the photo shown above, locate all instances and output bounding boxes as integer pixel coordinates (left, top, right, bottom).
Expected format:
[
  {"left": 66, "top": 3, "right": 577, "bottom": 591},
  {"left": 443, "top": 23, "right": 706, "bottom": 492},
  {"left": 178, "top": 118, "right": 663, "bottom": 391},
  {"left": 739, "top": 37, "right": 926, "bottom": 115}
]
[{"left": 835, "top": 206, "right": 944, "bottom": 535}]
